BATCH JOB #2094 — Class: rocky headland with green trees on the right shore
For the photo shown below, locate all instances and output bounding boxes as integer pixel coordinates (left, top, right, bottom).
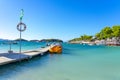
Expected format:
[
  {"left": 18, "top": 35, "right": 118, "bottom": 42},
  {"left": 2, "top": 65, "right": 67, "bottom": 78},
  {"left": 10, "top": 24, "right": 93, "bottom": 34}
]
[{"left": 69, "top": 25, "right": 120, "bottom": 46}]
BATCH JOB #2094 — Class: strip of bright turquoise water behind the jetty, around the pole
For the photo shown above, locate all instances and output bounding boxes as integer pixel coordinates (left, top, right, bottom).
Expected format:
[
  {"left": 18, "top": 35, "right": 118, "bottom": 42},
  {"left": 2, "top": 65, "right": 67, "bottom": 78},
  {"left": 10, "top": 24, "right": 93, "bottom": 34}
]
[{"left": 0, "top": 42, "right": 46, "bottom": 53}]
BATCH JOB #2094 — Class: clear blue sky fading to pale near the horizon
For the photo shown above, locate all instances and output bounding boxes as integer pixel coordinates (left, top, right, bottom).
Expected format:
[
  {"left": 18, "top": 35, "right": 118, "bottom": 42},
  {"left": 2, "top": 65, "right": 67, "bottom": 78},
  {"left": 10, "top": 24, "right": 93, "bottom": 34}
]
[{"left": 0, "top": 0, "right": 120, "bottom": 41}]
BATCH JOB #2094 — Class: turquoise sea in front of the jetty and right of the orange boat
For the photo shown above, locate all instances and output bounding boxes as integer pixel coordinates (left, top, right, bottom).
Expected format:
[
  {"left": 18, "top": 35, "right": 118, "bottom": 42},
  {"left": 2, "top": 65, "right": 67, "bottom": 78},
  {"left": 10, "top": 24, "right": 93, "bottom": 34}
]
[{"left": 0, "top": 43, "right": 120, "bottom": 80}]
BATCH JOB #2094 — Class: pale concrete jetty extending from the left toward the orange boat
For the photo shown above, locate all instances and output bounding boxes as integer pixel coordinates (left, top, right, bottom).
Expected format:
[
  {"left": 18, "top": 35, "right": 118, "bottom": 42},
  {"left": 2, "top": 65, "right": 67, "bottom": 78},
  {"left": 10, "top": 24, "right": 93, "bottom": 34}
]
[{"left": 0, "top": 46, "right": 53, "bottom": 65}]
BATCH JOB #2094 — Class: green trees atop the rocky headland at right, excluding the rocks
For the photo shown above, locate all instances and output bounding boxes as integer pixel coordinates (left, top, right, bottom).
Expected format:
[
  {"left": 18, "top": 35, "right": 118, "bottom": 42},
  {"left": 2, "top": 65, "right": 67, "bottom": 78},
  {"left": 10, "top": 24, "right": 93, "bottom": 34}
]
[{"left": 69, "top": 25, "right": 120, "bottom": 41}]
